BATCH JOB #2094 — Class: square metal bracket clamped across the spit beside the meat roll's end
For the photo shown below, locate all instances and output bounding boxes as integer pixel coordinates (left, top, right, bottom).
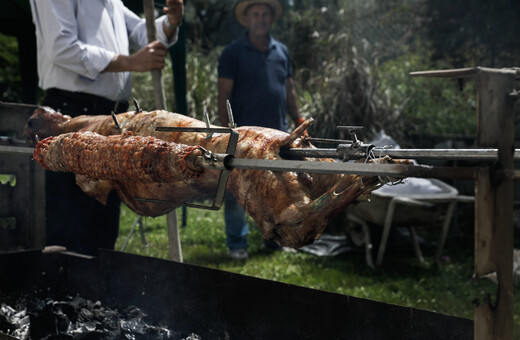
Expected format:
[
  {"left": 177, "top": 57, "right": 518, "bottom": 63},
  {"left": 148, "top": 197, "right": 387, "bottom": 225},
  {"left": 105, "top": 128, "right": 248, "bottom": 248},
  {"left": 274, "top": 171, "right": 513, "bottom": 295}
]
[{"left": 135, "top": 126, "right": 238, "bottom": 210}]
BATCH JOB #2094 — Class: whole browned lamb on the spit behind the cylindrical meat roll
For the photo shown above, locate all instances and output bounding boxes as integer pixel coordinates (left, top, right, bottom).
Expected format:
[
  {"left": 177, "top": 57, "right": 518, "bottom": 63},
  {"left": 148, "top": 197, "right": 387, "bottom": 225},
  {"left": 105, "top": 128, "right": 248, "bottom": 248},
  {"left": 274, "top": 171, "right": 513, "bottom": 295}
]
[{"left": 26, "top": 108, "right": 407, "bottom": 248}]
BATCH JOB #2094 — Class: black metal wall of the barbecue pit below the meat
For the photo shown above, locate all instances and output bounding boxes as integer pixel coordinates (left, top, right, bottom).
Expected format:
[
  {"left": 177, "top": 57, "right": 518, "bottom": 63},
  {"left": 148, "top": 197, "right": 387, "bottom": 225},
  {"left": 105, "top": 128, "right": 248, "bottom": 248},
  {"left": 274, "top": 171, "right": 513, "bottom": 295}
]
[{"left": 0, "top": 250, "right": 473, "bottom": 339}]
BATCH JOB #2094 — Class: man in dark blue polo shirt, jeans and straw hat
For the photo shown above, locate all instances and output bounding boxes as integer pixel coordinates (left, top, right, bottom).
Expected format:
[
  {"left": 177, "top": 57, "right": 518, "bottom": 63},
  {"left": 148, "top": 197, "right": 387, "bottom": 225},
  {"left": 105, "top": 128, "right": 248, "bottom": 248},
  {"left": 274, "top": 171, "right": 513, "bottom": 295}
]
[{"left": 218, "top": 0, "right": 304, "bottom": 259}]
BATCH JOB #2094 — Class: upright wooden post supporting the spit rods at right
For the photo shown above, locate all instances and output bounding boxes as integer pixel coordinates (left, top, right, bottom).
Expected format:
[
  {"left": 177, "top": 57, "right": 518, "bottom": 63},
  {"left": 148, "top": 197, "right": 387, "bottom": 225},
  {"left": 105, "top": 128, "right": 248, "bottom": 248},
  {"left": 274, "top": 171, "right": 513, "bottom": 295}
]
[{"left": 474, "top": 69, "right": 515, "bottom": 340}]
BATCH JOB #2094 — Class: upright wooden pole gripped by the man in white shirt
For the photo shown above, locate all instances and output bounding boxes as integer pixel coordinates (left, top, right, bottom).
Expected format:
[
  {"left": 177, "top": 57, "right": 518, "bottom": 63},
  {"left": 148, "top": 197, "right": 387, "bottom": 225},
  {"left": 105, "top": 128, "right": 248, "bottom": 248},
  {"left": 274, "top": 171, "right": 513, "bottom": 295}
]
[{"left": 143, "top": 0, "right": 182, "bottom": 262}]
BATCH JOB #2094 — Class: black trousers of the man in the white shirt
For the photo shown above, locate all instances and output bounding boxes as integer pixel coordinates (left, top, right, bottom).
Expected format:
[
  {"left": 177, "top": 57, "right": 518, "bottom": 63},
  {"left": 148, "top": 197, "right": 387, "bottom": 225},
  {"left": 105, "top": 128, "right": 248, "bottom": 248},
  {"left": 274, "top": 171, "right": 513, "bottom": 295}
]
[{"left": 42, "top": 90, "right": 128, "bottom": 256}]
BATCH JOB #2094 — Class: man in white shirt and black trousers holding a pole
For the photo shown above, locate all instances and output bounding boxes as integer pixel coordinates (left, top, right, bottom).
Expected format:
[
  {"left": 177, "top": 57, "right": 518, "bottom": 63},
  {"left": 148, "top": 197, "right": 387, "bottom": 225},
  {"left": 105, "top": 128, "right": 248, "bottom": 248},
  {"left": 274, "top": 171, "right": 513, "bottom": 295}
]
[{"left": 30, "top": 0, "right": 184, "bottom": 255}]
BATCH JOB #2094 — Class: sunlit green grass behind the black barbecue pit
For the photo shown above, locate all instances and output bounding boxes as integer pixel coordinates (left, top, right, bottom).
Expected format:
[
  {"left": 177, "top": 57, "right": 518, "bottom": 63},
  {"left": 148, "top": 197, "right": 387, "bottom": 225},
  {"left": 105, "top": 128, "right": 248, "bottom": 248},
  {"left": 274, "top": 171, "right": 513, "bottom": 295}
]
[{"left": 116, "top": 202, "right": 520, "bottom": 337}]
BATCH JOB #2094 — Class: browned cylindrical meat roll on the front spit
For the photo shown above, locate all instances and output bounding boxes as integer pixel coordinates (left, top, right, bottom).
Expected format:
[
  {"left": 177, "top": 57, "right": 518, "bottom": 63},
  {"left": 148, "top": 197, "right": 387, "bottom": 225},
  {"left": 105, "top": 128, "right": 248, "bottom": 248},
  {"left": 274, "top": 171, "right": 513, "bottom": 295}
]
[{"left": 34, "top": 131, "right": 204, "bottom": 183}]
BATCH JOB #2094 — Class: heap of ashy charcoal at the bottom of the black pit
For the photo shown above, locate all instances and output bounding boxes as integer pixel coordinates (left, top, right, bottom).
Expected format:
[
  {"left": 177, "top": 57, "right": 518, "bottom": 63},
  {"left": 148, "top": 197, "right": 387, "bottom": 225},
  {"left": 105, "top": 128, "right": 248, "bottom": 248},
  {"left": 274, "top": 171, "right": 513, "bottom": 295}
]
[{"left": 0, "top": 296, "right": 200, "bottom": 340}]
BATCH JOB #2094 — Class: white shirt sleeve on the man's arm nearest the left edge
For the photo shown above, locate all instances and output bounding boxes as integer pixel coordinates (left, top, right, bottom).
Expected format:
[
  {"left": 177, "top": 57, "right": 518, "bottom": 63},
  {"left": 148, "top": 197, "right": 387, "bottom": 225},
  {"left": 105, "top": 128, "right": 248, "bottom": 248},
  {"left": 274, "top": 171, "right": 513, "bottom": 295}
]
[{"left": 31, "top": 0, "right": 116, "bottom": 79}]
